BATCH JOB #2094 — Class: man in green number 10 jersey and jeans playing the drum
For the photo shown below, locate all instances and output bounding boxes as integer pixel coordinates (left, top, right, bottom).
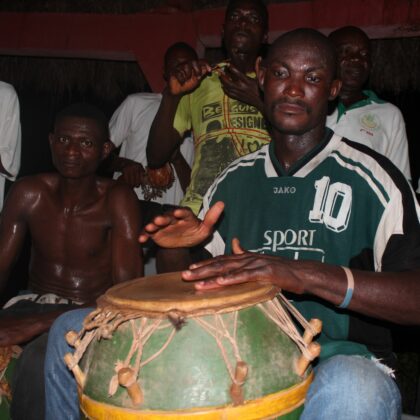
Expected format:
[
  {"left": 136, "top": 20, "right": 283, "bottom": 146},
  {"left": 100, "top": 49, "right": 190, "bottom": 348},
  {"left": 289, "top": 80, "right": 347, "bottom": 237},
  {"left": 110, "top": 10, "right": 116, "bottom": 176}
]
[{"left": 46, "top": 29, "right": 420, "bottom": 420}]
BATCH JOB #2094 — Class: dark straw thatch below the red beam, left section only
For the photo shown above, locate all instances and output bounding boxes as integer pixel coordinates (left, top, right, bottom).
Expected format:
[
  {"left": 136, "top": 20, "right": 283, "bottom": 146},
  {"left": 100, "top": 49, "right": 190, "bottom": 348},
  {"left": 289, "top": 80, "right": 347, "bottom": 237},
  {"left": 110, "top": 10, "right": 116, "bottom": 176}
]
[{"left": 0, "top": 55, "right": 150, "bottom": 113}]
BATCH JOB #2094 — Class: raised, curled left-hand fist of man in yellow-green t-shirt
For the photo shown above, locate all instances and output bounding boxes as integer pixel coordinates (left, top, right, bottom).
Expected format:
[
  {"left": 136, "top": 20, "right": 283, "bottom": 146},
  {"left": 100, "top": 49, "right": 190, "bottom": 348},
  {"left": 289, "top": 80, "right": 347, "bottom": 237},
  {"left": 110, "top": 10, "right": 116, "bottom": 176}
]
[{"left": 168, "top": 60, "right": 211, "bottom": 96}]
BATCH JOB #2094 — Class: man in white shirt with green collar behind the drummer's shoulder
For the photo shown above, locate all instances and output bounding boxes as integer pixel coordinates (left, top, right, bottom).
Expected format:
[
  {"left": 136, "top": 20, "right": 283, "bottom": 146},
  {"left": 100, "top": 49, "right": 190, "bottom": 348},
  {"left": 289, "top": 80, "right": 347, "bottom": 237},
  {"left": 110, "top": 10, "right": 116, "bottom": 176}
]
[{"left": 327, "top": 26, "right": 411, "bottom": 180}]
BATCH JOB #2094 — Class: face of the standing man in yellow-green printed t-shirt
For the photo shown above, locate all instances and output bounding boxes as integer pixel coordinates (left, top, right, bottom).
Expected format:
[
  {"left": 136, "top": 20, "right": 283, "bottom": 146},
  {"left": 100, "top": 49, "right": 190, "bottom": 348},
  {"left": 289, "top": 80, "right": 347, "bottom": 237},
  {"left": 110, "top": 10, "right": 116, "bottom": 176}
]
[{"left": 223, "top": 0, "right": 267, "bottom": 55}]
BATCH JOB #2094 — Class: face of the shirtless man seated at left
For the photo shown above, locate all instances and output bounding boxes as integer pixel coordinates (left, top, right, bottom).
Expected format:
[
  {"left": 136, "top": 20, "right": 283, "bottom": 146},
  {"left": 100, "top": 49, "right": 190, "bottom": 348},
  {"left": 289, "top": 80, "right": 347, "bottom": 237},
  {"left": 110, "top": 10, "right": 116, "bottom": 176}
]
[{"left": 49, "top": 116, "right": 110, "bottom": 179}]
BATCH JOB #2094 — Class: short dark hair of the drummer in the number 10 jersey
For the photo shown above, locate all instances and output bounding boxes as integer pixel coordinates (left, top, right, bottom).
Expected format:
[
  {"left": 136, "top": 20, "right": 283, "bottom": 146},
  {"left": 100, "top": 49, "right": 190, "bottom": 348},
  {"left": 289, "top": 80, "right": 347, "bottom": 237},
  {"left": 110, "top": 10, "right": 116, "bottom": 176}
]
[{"left": 267, "top": 28, "right": 337, "bottom": 78}]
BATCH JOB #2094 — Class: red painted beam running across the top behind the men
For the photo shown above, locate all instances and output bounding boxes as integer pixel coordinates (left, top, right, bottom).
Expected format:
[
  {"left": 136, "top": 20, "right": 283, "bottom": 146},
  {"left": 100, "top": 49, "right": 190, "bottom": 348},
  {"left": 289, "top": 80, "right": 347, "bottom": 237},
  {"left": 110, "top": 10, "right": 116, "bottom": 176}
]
[{"left": 0, "top": 0, "right": 420, "bottom": 91}]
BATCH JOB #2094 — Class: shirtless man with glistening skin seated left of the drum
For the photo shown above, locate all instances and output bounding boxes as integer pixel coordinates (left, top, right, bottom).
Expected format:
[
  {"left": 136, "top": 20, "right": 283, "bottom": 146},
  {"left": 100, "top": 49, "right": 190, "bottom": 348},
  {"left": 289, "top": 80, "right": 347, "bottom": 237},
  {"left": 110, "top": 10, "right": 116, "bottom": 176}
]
[{"left": 0, "top": 104, "right": 143, "bottom": 420}]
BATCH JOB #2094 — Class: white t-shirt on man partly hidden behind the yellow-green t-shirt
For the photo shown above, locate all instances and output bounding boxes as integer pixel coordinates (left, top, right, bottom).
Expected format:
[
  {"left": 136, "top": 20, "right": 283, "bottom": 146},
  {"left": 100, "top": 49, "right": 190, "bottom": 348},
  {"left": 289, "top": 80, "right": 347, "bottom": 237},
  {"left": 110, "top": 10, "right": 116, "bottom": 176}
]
[{"left": 109, "top": 93, "right": 194, "bottom": 205}]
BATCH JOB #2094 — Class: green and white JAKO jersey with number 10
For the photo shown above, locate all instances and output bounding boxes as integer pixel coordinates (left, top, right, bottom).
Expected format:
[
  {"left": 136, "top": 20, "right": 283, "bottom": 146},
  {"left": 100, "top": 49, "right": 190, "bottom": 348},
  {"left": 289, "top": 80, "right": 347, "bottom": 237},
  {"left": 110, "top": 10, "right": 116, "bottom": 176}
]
[{"left": 202, "top": 130, "right": 420, "bottom": 361}]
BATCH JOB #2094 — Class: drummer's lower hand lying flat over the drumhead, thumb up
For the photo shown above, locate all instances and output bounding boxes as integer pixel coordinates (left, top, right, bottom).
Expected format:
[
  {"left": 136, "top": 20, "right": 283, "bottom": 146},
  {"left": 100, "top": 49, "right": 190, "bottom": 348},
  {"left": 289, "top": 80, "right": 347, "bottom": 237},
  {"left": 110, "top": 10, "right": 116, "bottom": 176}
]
[{"left": 182, "top": 238, "right": 304, "bottom": 294}]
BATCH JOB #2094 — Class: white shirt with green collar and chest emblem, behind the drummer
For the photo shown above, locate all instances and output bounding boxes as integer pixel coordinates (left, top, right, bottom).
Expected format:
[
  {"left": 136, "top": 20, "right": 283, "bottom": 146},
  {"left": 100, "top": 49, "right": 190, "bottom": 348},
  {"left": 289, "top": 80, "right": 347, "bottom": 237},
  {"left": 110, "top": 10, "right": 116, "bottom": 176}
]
[{"left": 327, "top": 90, "right": 411, "bottom": 180}]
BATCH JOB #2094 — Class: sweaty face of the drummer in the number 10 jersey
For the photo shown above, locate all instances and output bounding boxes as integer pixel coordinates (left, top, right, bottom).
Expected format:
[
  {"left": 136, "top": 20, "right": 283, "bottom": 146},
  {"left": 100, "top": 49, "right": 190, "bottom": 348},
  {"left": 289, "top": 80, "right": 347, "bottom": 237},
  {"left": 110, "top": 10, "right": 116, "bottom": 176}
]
[{"left": 257, "top": 40, "right": 340, "bottom": 135}]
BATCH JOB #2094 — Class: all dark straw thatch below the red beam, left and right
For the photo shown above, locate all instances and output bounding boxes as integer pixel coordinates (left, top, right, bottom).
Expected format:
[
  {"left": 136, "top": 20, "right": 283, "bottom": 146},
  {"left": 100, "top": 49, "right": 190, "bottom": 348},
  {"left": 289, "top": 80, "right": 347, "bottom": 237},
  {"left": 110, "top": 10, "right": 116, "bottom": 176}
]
[{"left": 0, "top": 38, "right": 420, "bottom": 103}]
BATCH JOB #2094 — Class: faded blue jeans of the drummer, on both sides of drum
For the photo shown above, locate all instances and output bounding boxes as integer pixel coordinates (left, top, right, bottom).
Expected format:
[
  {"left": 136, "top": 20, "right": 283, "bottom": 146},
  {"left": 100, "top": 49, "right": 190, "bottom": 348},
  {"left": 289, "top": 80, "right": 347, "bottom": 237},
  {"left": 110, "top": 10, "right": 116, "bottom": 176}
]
[{"left": 45, "top": 308, "right": 401, "bottom": 420}]
